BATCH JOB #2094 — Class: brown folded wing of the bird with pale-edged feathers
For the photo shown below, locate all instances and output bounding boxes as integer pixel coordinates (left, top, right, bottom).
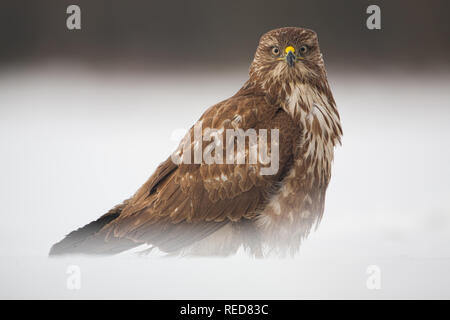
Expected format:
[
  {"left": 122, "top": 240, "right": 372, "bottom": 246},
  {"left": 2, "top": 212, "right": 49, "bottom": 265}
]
[{"left": 102, "top": 91, "right": 300, "bottom": 251}]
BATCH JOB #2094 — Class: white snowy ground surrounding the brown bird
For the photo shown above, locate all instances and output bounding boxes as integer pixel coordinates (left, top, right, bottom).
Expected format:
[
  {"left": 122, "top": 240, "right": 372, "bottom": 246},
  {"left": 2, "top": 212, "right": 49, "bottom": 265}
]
[{"left": 0, "top": 65, "right": 450, "bottom": 299}]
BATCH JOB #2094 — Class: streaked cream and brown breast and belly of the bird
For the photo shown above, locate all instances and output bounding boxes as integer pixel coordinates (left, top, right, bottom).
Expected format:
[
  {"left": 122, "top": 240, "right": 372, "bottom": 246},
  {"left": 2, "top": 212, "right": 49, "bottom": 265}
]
[{"left": 253, "top": 83, "right": 342, "bottom": 249}]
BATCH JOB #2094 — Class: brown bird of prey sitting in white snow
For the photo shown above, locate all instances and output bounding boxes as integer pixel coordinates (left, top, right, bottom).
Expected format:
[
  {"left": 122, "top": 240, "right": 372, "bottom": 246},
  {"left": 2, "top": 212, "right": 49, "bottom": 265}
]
[{"left": 50, "top": 27, "right": 342, "bottom": 257}]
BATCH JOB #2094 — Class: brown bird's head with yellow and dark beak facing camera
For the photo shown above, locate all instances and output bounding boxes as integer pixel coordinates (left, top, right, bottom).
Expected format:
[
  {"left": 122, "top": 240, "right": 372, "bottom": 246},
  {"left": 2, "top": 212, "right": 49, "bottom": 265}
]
[{"left": 250, "top": 27, "right": 325, "bottom": 83}]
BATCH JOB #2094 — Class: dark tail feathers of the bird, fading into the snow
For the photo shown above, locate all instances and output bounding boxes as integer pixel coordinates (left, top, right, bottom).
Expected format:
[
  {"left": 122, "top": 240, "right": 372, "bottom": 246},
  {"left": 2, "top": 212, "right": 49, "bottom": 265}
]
[{"left": 49, "top": 202, "right": 139, "bottom": 256}]
